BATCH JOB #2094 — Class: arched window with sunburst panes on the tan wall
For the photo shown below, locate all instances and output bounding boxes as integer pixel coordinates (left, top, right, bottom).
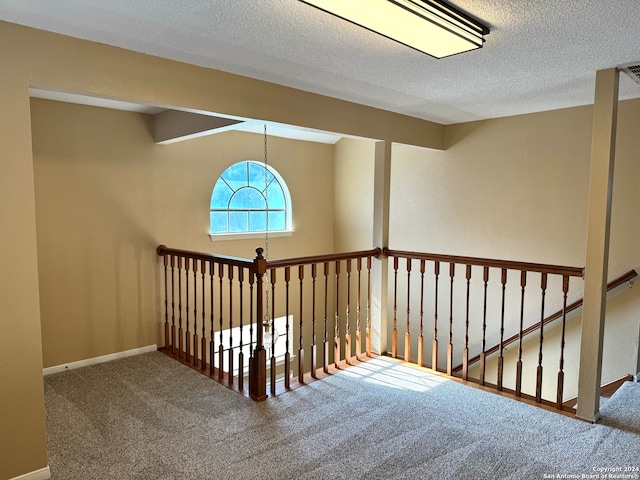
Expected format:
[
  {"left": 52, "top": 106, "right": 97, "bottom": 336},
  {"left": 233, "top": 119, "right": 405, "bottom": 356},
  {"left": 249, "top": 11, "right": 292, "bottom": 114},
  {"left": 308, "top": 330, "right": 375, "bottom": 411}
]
[{"left": 210, "top": 160, "right": 291, "bottom": 235}]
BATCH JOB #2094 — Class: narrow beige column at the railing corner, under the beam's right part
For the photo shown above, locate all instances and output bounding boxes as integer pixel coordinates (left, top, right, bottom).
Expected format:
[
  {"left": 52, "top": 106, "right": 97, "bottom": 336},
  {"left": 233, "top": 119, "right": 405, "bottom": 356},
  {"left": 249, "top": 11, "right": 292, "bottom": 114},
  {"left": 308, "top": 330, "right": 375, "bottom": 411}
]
[{"left": 371, "top": 141, "right": 391, "bottom": 354}]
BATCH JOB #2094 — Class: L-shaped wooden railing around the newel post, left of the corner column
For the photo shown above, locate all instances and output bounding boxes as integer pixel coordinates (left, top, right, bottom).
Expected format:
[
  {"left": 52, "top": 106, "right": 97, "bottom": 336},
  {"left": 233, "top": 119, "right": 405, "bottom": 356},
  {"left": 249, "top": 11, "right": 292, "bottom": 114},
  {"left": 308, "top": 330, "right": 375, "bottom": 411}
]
[{"left": 157, "top": 245, "right": 380, "bottom": 400}]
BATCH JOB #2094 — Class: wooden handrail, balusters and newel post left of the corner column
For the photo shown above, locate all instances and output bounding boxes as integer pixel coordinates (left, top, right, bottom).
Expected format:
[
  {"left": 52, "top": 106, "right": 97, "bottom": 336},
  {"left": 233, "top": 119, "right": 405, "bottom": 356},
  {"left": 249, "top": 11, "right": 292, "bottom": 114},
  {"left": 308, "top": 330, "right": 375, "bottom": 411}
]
[{"left": 156, "top": 245, "right": 382, "bottom": 400}]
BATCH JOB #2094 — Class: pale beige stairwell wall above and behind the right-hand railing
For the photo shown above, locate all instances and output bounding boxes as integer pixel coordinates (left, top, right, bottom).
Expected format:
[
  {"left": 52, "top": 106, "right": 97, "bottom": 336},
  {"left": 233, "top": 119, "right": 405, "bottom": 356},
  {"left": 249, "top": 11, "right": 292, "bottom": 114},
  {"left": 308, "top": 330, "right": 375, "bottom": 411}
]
[{"left": 390, "top": 101, "right": 640, "bottom": 402}]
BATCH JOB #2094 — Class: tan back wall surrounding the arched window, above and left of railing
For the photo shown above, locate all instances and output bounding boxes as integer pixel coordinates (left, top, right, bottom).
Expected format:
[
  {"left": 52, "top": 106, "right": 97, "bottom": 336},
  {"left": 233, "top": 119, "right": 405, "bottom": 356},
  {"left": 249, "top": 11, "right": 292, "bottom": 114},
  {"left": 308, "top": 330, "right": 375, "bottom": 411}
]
[{"left": 32, "top": 99, "right": 333, "bottom": 367}]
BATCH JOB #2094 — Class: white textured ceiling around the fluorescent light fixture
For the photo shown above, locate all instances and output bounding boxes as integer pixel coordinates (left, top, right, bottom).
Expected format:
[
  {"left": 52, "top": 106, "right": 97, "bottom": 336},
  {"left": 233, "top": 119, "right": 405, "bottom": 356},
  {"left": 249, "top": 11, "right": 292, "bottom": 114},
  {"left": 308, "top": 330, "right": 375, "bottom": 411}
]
[{"left": 0, "top": 0, "right": 640, "bottom": 124}]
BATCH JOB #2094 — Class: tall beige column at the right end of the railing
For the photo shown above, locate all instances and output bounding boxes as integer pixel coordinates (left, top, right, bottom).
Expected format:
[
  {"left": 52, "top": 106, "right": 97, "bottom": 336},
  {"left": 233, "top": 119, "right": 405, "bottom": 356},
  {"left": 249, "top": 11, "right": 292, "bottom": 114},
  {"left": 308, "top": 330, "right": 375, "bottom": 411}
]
[{"left": 576, "top": 68, "right": 619, "bottom": 422}]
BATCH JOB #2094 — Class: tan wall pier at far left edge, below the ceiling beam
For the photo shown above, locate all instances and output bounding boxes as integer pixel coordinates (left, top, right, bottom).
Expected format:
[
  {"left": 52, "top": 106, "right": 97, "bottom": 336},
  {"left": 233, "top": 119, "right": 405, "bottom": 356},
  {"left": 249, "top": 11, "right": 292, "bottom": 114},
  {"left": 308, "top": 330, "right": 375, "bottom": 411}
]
[{"left": 0, "top": 69, "right": 49, "bottom": 479}]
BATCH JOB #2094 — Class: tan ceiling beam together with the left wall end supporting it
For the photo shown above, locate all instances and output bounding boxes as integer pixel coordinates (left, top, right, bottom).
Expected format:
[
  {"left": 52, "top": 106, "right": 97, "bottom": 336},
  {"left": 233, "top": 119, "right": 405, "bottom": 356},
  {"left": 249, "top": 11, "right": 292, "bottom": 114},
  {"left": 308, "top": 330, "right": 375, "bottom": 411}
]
[{"left": 0, "top": 17, "right": 444, "bottom": 479}]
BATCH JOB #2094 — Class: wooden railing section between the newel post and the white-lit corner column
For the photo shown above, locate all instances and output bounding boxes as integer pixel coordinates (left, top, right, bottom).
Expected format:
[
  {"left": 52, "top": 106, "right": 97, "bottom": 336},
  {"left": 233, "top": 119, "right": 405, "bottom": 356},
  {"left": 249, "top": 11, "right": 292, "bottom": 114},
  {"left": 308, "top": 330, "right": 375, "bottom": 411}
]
[{"left": 265, "top": 249, "right": 380, "bottom": 395}]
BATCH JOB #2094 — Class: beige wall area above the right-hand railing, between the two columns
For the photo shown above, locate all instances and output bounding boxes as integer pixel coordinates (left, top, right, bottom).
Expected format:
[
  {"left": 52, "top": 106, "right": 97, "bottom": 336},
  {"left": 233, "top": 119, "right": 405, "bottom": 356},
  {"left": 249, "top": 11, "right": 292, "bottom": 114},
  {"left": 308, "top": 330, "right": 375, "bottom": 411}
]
[{"left": 390, "top": 107, "right": 591, "bottom": 266}]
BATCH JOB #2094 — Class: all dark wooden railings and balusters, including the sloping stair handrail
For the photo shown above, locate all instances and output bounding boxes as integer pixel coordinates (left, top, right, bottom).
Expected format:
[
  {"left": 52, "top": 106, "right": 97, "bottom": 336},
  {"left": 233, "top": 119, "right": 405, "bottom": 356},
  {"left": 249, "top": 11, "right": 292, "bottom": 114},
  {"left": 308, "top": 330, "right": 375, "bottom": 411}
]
[{"left": 157, "top": 245, "right": 620, "bottom": 408}]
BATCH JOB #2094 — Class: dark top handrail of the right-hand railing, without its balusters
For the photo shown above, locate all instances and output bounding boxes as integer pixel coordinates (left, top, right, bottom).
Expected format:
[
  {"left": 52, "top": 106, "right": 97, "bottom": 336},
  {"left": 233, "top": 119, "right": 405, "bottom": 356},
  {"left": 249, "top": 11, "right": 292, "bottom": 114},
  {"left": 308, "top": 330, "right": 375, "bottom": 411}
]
[{"left": 382, "top": 248, "right": 584, "bottom": 277}]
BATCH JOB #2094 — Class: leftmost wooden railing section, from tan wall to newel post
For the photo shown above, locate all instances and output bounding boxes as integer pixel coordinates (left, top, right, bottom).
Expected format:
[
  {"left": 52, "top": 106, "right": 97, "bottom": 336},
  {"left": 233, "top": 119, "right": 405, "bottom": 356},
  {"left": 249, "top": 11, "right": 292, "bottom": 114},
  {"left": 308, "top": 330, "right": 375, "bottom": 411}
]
[{"left": 157, "top": 245, "right": 265, "bottom": 398}]
